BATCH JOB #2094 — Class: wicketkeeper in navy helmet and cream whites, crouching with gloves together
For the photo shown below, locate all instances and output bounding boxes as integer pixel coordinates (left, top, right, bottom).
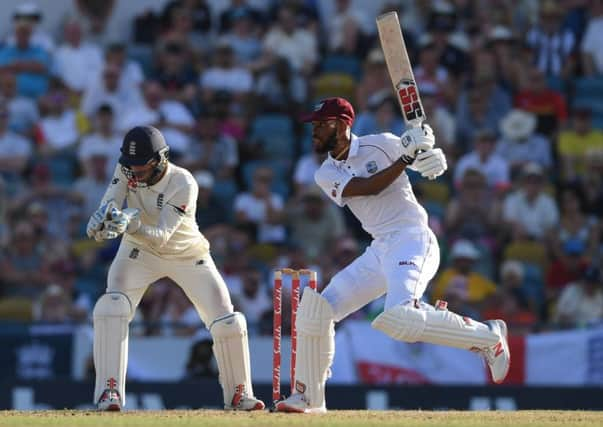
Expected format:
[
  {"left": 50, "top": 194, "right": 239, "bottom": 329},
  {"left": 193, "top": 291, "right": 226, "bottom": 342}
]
[{"left": 86, "top": 126, "right": 264, "bottom": 411}]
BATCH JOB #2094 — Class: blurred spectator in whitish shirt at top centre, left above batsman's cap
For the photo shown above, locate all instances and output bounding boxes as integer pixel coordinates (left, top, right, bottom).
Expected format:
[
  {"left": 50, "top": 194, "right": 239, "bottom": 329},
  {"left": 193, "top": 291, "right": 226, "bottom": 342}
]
[{"left": 263, "top": 4, "right": 318, "bottom": 77}]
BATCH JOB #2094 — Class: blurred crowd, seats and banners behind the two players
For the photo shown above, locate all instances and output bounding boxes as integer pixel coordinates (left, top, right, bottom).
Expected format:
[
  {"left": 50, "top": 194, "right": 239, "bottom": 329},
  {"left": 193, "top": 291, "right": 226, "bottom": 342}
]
[{"left": 0, "top": 0, "right": 603, "bottom": 409}]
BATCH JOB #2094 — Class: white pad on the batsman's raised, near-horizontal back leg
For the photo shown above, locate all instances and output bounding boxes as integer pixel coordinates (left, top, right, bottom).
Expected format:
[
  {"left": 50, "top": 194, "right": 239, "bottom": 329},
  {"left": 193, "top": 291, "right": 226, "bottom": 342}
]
[{"left": 371, "top": 302, "right": 500, "bottom": 350}]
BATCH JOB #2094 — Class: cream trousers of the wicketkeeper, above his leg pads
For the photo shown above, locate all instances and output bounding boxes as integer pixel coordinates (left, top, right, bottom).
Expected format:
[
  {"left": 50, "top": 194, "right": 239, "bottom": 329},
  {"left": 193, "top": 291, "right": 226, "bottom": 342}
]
[{"left": 107, "top": 241, "right": 233, "bottom": 327}]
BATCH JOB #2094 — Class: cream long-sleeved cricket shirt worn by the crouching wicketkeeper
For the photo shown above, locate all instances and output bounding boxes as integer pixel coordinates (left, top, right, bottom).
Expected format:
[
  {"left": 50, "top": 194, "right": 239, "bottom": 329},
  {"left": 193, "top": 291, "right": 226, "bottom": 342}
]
[{"left": 101, "top": 163, "right": 209, "bottom": 259}]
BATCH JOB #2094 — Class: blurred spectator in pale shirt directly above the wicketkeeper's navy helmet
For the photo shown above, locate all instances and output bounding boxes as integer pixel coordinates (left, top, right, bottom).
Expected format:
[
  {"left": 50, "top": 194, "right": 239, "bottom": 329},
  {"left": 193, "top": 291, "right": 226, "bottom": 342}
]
[{"left": 117, "top": 80, "right": 195, "bottom": 159}]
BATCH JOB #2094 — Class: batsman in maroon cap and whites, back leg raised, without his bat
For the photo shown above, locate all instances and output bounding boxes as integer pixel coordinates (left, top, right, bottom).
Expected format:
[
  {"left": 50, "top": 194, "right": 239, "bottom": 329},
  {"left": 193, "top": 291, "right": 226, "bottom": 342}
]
[{"left": 275, "top": 98, "right": 510, "bottom": 413}]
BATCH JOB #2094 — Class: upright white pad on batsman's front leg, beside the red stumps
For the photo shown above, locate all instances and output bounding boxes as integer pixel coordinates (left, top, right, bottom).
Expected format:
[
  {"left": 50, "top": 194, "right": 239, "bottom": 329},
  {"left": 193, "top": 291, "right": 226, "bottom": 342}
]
[{"left": 295, "top": 287, "right": 335, "bottom": 408}]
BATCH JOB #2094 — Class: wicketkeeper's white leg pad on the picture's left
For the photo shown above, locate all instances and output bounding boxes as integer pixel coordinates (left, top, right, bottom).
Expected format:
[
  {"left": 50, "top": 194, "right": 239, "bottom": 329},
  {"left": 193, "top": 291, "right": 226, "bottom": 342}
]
[{"left": 93, "top": 292, "right": 132, "bottom": 407}]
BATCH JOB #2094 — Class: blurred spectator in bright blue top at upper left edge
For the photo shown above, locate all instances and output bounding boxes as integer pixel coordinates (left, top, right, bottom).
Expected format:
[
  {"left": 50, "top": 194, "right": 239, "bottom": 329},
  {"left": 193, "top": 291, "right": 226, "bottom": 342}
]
[{"left": 0, "top": 16, "right": 51, "bottom": 98}]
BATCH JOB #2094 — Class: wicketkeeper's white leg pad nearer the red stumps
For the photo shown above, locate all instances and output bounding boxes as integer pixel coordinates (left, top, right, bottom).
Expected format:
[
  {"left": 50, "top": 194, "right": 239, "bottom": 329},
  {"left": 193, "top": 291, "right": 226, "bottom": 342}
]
[{"left": 209, "top": 312, "right": 253, "bottom": 405}]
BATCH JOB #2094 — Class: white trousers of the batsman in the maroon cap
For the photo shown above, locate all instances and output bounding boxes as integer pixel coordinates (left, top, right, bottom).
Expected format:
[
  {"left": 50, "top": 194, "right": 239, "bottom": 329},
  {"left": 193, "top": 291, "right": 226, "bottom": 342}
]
[{"left": 322, "top": 227, "right": 440, "bottom": 321}]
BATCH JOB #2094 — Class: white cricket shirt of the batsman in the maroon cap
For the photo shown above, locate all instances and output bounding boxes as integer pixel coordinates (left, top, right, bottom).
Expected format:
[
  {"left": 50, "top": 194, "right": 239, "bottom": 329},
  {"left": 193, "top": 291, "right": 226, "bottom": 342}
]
[{"left": 314, "top": 133, "right": 427, "bottom": 238}]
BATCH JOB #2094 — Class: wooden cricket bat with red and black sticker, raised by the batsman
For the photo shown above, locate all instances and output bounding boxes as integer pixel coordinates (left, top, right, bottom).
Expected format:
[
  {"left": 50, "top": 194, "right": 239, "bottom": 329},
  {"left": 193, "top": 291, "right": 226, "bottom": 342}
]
[{"left": 377, "top": 12, "right": 425, "bottom": 127}]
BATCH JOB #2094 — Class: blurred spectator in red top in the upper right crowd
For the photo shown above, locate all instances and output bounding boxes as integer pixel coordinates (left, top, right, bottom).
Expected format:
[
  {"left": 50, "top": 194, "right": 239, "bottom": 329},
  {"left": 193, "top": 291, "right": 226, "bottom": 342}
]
[{"left": 513, "top": 67, "right": 567, "bottom": 137}]
